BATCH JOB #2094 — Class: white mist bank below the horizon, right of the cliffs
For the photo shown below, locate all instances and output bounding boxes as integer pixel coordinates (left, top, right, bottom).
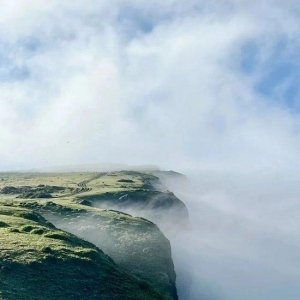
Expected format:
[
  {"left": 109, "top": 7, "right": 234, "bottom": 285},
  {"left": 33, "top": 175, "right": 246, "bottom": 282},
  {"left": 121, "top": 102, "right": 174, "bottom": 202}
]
[{"left": 161, "top": 172, "right": 300, "bottom": 300}]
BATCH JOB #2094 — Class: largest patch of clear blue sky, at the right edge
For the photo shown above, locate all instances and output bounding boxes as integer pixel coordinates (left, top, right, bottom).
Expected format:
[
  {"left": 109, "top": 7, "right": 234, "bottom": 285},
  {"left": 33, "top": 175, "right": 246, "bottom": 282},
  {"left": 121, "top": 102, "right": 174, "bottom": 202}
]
[{"left": 241, "top": 39, "right": 300, "bottom": 112}]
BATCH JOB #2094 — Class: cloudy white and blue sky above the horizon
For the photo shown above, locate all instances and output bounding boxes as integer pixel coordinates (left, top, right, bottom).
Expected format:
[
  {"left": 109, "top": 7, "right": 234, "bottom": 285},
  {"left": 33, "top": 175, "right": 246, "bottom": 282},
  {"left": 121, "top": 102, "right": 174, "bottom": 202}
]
[{"left": 0, "top": 0, "right": 300, "bottom": 172}]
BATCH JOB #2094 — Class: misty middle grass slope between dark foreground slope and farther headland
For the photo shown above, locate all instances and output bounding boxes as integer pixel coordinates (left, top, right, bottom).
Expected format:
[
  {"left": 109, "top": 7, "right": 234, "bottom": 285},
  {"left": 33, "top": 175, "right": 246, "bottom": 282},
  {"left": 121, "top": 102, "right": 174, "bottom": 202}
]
[{"left": 20, "top": 202, "right": 177, "bottom": 300}]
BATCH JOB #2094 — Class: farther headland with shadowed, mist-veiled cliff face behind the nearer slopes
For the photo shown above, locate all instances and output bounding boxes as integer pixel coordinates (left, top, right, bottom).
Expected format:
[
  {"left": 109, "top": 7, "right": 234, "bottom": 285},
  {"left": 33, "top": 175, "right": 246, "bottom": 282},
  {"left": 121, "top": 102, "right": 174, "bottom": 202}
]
[{"left": 75, "top": 171, "right": 189, "bottom": 232}]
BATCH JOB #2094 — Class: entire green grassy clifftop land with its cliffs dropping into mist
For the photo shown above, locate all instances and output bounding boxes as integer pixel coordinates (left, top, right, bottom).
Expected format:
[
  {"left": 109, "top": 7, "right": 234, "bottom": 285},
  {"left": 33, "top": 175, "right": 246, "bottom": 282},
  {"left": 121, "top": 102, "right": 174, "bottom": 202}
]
[{"left": 0, "top": 171, "right": 189, "bottom": 300}]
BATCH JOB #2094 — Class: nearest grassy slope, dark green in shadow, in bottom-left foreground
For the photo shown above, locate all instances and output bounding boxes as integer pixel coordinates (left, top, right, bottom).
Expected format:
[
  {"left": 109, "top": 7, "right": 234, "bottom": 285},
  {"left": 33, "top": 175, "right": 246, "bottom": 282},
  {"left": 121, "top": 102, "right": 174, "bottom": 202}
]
[{"left": 0, "top": 206, "right": 165, "bottom": 300}]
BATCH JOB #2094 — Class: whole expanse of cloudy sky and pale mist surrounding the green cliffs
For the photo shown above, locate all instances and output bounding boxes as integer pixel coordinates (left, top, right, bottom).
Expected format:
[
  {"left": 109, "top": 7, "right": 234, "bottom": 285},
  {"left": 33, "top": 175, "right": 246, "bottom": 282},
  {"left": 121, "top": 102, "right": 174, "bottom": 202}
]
[{"left": 0, "top": 0, "right": 300, "bottom": 300}]
